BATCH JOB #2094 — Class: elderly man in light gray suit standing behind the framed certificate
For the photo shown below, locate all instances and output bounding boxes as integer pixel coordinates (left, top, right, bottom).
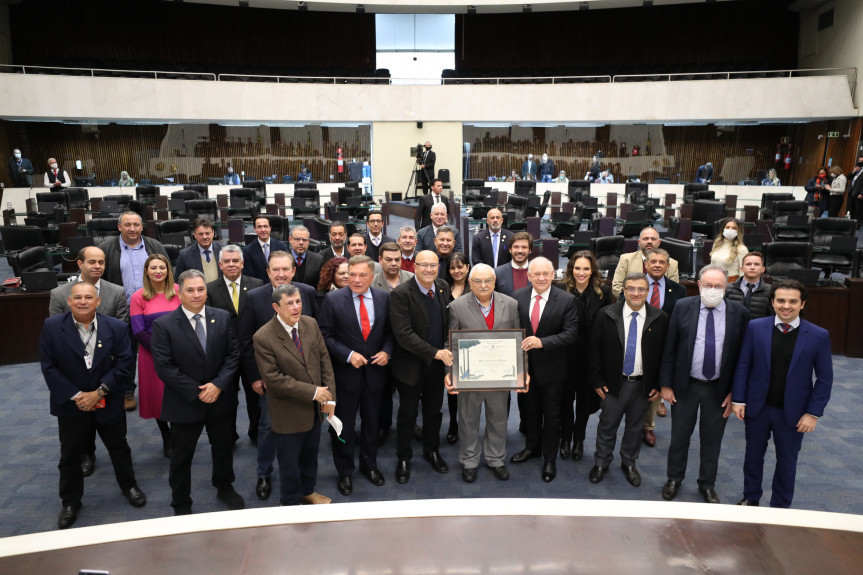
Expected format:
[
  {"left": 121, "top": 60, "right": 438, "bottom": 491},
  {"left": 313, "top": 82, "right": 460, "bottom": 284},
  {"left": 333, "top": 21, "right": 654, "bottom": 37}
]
[{"left": 444, "top": 264, "right": 530, "bottom": 483}]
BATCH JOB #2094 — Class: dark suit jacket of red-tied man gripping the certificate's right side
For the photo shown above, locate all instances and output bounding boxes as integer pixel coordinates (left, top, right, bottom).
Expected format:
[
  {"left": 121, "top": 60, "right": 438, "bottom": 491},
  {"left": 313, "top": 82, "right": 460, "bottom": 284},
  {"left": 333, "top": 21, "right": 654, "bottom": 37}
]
[{"left": 512, "top": 286, "right": 578, "bottom": 385}]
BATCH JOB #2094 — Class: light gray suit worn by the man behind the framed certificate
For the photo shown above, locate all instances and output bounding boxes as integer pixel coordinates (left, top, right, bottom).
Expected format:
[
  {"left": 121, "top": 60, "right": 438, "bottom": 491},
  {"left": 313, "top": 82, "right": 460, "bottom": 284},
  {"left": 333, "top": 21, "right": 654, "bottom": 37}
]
[{"left": 449, "top": 292, "right": 527, "bottom": 469}]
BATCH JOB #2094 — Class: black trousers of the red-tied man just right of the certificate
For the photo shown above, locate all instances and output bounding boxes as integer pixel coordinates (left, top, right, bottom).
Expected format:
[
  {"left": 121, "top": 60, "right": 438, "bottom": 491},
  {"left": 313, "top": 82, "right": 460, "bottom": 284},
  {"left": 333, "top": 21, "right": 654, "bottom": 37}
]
[{"left": 518, "top": 377, "right": 566, "bottom": 461}]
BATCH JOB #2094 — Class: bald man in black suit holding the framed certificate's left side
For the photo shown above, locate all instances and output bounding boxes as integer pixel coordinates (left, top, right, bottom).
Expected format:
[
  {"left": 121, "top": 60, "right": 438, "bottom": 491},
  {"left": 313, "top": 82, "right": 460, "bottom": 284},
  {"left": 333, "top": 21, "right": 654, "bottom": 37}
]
[{"left": 390, "top": 250, "right": 452, "bottom": 483}]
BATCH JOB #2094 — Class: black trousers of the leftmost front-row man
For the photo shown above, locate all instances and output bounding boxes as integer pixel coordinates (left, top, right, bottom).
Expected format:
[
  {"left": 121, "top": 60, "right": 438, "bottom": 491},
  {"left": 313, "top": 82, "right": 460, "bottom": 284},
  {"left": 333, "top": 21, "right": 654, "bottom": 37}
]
[{"left": 57, "top": 412, "right": 135, "bottom": 505}]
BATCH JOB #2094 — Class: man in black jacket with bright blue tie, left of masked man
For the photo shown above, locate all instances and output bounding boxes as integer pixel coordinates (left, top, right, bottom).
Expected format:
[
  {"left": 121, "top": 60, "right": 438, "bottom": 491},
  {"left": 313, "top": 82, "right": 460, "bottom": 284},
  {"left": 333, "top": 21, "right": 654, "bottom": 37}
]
[{"left": 588, "top": 273, "right": 668, "bottom": 487}]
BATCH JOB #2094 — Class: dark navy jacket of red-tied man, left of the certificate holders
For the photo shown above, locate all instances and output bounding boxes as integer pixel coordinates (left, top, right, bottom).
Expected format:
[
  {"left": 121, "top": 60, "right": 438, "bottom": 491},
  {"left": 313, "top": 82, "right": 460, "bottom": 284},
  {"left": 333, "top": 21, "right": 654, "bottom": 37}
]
[{"left": 318, "top": 287, "right": 393, "bottom": 393}]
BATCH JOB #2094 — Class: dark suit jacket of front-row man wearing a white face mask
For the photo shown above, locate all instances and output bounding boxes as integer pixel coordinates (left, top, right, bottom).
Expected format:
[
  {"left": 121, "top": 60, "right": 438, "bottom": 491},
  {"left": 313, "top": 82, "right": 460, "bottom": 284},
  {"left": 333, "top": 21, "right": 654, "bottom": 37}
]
[{"left": 656, "top": 296, "right": 749, "bottom": 403}]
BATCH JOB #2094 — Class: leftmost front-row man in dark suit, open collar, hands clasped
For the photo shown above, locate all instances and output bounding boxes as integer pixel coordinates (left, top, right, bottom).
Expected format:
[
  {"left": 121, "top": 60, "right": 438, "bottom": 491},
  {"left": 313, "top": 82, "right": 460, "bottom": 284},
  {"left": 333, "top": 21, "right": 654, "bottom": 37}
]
[{"left": 39, "top": 282, "right": 147, "bottom": 529}]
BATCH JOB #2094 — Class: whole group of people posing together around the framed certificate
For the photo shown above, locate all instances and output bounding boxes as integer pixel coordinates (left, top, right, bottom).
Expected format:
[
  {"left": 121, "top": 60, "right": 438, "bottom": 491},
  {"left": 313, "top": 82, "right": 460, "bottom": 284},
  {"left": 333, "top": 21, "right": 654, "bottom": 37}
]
[{"left": 41, "top": 189, "right": 832, "bottom": 528}]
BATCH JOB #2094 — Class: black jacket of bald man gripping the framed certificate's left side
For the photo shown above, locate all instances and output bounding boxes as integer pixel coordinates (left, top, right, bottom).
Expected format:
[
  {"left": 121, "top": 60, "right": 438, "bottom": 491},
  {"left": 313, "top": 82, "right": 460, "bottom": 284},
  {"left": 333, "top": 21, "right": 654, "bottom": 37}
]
[{"left": 390, "top": 279, "right": 452, "bottom": 385}]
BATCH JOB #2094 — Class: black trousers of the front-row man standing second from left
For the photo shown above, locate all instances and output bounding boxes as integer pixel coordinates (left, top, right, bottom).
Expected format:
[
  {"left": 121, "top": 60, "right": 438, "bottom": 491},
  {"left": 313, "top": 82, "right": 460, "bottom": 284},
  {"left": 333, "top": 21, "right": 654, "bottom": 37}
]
[{"left": 168, "top": 411, "right": 234, "bottom": 507}]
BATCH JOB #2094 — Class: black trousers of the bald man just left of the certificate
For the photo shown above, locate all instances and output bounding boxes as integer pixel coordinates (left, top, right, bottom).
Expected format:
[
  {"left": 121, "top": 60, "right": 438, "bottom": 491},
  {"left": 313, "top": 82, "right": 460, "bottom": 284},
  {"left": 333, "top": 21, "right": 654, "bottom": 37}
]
[{"left": 396, "top": 361, "right": 444, "bottom": 459}]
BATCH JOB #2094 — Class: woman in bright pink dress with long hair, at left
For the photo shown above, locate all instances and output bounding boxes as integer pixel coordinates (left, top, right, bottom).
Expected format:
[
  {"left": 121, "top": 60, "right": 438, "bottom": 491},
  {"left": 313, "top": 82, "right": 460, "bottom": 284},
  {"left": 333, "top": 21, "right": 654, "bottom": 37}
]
[{"left": 129, "top": 254, "right": 180, "bottom": 457}]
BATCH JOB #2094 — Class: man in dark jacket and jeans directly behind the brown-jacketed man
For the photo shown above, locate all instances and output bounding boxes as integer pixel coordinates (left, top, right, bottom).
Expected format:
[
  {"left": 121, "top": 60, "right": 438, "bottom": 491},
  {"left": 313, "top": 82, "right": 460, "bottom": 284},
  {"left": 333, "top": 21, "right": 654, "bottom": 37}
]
[{"left": 239, "top": 251, "right": 318, "bottom": 500}]
